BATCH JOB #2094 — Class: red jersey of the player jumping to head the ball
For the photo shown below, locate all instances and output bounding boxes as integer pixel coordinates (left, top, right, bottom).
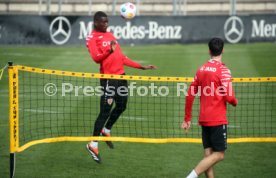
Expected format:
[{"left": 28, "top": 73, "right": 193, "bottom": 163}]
[{"left": 86, "top": 30, "right": 141, "bottom": 75}]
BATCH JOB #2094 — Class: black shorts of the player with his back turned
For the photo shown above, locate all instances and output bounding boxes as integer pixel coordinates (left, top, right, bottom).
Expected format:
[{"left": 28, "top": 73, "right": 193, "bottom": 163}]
[{"left": 202, "top": 125, "right": 227, "bottom": 151}]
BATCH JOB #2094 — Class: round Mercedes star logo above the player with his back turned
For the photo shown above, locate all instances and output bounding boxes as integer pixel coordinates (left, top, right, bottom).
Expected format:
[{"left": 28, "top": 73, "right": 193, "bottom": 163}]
[{"left": 224, "top": 16, "right": 244, "bottom": 43}]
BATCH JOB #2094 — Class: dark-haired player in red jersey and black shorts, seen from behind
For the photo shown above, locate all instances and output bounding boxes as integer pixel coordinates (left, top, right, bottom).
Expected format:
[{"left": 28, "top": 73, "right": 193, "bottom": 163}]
[{"left": 182, "top": 38, "right": 238, "bottom": 178}]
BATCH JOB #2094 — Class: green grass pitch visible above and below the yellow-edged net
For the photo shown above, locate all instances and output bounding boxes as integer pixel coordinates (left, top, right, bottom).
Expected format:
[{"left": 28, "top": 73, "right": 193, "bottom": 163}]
[{"left": 0, "top": 43, "right": 276, "bottom": 178}]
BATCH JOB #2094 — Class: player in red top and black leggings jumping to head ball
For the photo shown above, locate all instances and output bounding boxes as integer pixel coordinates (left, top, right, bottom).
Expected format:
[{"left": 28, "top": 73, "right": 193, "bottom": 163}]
[{"left": 86, "top": 11, "right": 156, "bottom": 163}]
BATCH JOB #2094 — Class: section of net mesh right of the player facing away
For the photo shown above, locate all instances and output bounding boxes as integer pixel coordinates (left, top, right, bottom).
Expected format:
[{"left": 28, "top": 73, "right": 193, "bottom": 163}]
[{"left": 228, "top": 82, "right": 276, "bottom": 137}]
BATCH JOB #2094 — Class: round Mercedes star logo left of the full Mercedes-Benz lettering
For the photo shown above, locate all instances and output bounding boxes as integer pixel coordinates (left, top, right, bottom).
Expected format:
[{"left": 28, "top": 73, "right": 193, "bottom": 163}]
[{"left": 50, "top": 16, "right": 71, "bottom": 45}]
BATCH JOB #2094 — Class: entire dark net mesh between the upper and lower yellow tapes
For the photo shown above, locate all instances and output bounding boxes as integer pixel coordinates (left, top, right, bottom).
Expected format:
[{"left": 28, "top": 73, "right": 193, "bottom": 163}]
[{"left": 16, "top": 68, "right": 276, "bottom": 145}]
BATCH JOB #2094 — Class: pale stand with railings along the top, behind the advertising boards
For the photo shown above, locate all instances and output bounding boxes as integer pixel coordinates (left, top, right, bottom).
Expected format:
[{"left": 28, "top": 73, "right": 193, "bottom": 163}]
[{"left": 0, "top": 0, "right": 276, "bottom": 16}]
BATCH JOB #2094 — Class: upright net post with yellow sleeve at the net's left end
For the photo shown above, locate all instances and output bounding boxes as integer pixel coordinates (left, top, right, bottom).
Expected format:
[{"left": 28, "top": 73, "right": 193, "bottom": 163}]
[{"left": 8, "top": 62, "right": 15, "bottom": 178}]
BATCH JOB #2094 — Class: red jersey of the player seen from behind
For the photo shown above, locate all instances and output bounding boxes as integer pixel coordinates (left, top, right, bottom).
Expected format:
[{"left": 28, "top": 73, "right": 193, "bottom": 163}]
[{"left": 184, "top": 59, "right": 237, "bottom": 126}]
